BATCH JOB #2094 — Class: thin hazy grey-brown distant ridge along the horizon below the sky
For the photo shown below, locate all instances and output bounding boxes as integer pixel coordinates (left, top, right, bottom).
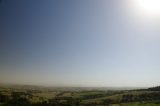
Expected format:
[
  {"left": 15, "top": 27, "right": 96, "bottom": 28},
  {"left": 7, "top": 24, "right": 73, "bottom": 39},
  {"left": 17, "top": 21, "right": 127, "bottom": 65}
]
[{"left": 0, "top": 83, "right": 142, "bottom": 91}]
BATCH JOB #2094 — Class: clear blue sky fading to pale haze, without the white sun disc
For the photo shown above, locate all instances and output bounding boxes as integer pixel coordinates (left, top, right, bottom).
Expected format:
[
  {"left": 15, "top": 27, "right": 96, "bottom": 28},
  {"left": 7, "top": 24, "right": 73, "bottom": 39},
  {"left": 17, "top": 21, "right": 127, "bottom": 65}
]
[{"left": 0, "top": 0, "right": 160, "bottom": 87}]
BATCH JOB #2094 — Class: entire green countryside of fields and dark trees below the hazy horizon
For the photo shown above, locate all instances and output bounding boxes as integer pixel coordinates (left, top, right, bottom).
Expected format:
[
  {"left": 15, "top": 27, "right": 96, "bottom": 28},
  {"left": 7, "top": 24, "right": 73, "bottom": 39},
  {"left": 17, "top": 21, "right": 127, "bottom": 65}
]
[{"left": 0, "top": 87, "right": 160, "bottom": 106}]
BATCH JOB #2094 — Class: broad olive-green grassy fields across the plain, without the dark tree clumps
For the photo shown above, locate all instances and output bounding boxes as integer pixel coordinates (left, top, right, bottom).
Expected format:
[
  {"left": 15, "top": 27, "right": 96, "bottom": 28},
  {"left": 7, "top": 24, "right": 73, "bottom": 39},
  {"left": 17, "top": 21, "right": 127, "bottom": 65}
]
[{"left": 0, "top": 87, "right": 160, "bottom": 106}]
